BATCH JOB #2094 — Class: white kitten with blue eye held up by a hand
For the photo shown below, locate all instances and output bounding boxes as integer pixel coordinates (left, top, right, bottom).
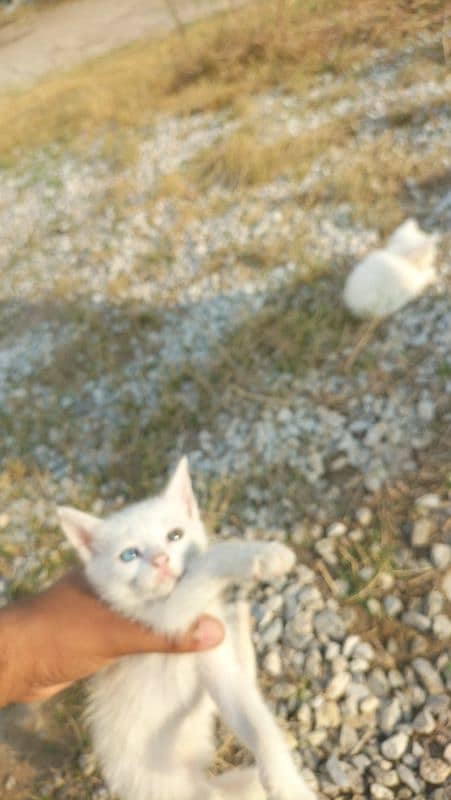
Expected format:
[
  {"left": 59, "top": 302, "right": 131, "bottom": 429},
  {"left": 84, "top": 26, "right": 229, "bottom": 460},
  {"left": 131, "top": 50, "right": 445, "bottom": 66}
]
[{"left": 59, "top": 459, "right": 314, "bottom": 800}]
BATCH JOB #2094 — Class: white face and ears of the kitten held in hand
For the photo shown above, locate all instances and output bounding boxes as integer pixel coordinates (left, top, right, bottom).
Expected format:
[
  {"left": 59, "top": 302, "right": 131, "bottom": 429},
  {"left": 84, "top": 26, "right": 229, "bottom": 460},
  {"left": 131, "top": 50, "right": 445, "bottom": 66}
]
[{"left": 59, "top": 459, "right": 206, "bottom": 619}]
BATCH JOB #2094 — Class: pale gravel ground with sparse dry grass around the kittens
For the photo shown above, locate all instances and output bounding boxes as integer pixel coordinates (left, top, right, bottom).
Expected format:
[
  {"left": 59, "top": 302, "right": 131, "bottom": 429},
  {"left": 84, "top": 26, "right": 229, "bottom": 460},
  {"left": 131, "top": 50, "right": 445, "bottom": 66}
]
[{"left": 0, "top": 26, "right": 451, "bottom": 800}]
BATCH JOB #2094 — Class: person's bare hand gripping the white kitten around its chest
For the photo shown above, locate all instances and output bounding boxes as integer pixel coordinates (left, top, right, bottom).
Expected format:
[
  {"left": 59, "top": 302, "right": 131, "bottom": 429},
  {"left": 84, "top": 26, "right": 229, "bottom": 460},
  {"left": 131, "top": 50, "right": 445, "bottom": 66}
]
[{"left": 0, "top": 570, "right": 224, "bottom": 706}]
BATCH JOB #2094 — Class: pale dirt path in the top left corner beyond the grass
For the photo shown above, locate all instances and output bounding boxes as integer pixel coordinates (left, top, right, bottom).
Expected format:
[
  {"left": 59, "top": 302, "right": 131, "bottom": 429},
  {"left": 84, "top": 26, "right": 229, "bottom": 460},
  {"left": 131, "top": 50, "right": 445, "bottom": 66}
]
[{"left": 0, "top": 0, "right": 242, "bottom": 87}]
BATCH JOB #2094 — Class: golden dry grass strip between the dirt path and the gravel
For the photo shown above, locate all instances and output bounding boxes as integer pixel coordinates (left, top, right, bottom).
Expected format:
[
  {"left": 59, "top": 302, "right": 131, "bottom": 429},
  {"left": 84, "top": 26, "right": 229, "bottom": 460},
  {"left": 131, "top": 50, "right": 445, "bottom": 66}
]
[{"left": 0, "top": 0, "right": 445, "bottom": 162}]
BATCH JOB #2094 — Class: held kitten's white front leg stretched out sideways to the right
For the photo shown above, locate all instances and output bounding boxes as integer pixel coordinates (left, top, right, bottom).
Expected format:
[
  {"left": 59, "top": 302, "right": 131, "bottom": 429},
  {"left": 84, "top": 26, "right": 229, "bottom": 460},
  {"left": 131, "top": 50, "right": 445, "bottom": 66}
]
[{"left": 148, "top": 541, "right": 295, "bottom": 634}]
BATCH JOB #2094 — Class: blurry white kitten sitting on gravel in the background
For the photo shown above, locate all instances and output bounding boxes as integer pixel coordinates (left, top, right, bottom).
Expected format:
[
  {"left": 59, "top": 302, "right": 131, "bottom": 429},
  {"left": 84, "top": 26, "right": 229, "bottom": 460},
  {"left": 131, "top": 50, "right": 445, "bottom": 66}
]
[{"left": 343, "top": 219, "right": 437, "bottom": 318}]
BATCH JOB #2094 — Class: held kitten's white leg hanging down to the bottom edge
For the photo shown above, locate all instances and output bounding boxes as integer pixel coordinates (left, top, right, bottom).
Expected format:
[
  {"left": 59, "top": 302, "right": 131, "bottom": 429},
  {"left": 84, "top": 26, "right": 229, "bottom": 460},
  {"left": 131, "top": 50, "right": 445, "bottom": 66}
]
[{"left": 199, "top": 635, "right": 315, "bottom": 800}]
